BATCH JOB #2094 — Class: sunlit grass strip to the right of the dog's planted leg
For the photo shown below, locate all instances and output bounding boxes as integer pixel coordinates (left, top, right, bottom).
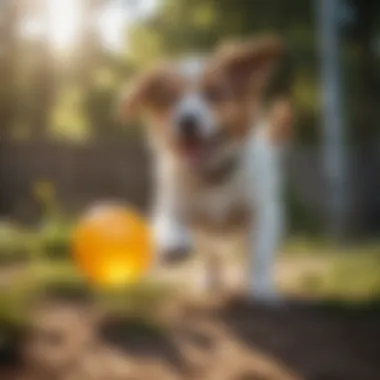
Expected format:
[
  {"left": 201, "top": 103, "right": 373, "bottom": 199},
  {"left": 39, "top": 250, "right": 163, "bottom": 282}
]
[{"left": 282, "top": 239, "right": 380, "bottom": 301}]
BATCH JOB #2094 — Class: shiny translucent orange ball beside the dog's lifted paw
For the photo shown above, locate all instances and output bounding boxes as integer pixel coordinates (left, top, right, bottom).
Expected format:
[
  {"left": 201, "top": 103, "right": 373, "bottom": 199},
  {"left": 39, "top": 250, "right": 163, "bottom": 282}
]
[{"left": 73, "top": 205, "right": 153, "bottom": 287}]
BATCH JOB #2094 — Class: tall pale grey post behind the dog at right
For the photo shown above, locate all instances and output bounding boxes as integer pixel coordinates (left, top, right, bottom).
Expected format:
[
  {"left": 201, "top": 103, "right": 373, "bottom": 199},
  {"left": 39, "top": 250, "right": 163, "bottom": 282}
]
[{"left": 316, "top": 0, "right": 348, "bottom": 238}]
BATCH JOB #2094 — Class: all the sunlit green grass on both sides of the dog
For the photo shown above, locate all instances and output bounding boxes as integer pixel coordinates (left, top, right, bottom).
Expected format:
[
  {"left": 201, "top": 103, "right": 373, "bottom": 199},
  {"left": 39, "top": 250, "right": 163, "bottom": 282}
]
[{"left": 0, "top": 214, "right": 380, "bottom": 330}]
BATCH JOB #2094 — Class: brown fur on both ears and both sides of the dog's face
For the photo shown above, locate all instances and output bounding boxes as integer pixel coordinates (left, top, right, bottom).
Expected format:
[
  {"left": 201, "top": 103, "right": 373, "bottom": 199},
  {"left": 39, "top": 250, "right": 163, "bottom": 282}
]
[{"left": 122, "top": 37, "right": 283, "bottom": 153}]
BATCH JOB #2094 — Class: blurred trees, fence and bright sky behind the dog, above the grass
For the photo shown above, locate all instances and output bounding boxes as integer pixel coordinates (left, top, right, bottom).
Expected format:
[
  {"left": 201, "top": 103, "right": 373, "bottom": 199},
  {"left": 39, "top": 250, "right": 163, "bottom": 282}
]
[{"left": 0, "top": 0, "right": 380, "bottom": 237}]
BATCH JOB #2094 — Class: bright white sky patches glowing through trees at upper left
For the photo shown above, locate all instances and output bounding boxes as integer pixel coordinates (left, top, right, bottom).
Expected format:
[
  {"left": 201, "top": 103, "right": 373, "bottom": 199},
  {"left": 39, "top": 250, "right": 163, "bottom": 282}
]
[{"left": 22, "top": 0, "right": 159, "bottom": 51}]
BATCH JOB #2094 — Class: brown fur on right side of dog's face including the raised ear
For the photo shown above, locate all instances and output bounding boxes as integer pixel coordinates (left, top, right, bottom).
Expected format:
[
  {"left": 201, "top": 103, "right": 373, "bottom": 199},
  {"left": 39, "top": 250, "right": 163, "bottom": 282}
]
[{"left": 203, "top": 37, "right": 283, "bottom": 139}]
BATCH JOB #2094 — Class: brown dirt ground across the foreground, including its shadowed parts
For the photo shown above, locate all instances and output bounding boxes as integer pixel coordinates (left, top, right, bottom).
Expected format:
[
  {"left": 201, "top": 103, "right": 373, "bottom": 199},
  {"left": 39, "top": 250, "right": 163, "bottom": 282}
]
[{"left": 0, "top": 296, "right": 380, "bottom": 380}]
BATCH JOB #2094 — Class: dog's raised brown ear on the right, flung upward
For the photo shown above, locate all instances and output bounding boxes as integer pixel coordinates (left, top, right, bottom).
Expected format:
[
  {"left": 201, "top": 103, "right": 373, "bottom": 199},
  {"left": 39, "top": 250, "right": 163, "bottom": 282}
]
[{"left": 217, "top": 36, "right": 284, "bottom": 94}]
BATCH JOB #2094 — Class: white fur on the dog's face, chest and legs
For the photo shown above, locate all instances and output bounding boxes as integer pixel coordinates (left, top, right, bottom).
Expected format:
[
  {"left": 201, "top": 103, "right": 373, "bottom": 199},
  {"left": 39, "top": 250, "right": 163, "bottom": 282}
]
[{"left": 149, "top": 60, "right": 284, "bottom": 299}]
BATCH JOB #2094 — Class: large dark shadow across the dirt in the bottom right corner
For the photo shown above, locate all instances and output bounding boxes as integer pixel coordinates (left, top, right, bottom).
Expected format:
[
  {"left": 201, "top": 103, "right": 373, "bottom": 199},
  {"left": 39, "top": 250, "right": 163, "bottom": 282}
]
[{"left": 216, "top": 298, "right": 380, "bottom": 380}]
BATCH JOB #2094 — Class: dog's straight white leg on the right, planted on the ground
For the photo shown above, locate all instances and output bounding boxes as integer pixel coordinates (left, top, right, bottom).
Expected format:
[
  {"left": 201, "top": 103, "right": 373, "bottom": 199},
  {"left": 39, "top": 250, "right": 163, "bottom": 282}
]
[{"left": 249, "top": 132, "right": 284, "bottom": 301}]
